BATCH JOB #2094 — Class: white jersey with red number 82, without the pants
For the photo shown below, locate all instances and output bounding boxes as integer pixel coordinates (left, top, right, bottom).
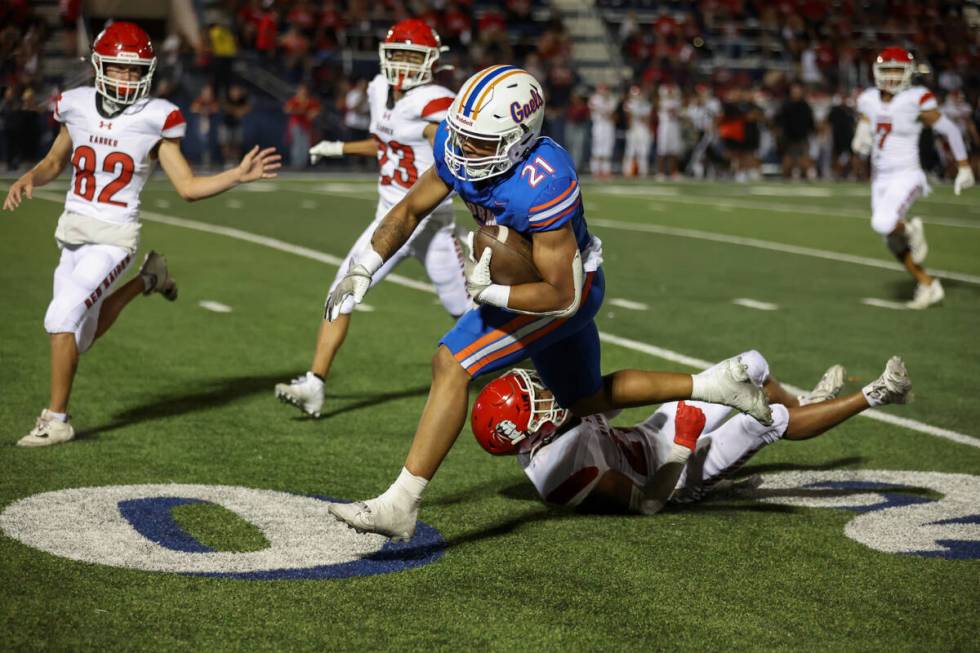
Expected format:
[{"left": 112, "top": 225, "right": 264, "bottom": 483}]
[{"left": 54, "top": 86, "right": 187, "bottom": 224}]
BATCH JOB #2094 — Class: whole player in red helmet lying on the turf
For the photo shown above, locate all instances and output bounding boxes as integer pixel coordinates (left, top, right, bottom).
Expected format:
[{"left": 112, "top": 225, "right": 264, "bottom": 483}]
[{"left": 471, "top": 351, "right": 912, "bottom": 515}]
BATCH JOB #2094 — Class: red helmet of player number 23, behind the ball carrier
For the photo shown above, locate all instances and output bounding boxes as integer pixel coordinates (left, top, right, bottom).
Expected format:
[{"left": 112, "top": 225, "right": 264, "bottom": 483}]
[{"left": 378, "top": 18, "right": 446, "bottom": 90}]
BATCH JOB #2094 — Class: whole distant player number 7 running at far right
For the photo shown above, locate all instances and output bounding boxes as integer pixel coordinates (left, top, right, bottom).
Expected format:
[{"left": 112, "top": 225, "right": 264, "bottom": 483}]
[{"left": 851, "top": 48, "right": 974, "bottom": 309}]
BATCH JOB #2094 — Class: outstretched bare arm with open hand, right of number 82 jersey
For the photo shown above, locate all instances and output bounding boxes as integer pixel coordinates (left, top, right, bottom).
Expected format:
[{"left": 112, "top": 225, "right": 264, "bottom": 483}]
[{"left": 157, "top": 138, "right": 282, "bottom": 202}]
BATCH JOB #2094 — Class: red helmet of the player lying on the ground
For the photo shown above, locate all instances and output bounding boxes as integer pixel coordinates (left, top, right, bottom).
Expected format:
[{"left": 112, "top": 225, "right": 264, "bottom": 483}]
[{"left": 470, "top": 369, "right": 569, "bottom": 456}]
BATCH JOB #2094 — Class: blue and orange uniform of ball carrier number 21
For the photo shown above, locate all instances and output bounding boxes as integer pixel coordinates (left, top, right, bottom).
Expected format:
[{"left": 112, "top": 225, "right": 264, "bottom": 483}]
[{"left": 432, "top": 122, "right": 605, "bottom": 406}]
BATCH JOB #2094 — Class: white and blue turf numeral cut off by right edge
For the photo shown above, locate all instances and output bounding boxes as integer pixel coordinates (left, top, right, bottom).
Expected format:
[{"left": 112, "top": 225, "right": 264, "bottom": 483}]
[{"left": 752, "top": 470, "right": 980, "bottom": 560}]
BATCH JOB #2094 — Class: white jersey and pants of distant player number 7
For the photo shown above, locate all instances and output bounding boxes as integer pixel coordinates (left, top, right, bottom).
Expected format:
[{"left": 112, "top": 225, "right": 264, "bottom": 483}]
[{"left": 857, "top": 86, "right": 939, "bottom": 235}]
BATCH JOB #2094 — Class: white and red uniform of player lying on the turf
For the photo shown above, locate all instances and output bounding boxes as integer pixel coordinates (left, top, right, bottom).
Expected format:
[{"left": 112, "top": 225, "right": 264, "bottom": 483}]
[{"left": 517, "top": 351, "right": 789, "bottom": 507}]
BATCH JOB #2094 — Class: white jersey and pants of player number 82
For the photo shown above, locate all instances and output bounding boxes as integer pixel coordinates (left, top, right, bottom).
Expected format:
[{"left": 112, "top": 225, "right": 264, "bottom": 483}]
[{"left": 44, "top": 86, "right": 186, "bottom": 351}]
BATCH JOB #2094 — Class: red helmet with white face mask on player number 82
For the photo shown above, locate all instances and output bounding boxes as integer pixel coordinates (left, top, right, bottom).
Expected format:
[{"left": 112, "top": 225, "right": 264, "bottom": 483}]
[{"left": 92, "top": 23, "right": 157, "bottom": 104}]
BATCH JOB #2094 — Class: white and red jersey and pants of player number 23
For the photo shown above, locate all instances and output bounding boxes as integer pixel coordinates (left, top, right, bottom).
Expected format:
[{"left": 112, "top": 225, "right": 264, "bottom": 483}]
[{"left": 330, "top": 75, "right": 470, "bottom": 315}]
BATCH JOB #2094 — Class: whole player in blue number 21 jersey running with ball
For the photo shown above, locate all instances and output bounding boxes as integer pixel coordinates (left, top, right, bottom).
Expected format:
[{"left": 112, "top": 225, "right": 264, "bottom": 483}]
[{"left": 326, "top": 66, "right": 772, "bottom": 539}]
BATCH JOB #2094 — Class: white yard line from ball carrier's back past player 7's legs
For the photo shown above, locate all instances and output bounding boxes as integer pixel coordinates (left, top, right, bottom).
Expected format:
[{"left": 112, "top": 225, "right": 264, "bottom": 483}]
[{"left": 588, "top": 218, "right": 980, "bottom": 285}]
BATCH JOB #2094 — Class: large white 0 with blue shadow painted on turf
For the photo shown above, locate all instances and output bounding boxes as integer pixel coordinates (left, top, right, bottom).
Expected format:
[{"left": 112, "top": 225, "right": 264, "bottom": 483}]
[{"left": 0, "top": 484, "right": 445, "bottom": 580}]
